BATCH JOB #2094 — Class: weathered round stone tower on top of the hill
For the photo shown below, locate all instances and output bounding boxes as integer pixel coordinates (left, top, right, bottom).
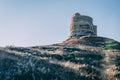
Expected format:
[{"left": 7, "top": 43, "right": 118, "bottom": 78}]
[{"left": 70, "top": 13, "right": 97, "bottom": 38}]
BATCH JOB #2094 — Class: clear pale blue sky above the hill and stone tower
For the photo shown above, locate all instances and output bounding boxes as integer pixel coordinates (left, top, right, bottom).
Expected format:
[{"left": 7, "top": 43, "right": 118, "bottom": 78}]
[{"left": 0, "top": 0, "right": 120, "bottom": 46}]
